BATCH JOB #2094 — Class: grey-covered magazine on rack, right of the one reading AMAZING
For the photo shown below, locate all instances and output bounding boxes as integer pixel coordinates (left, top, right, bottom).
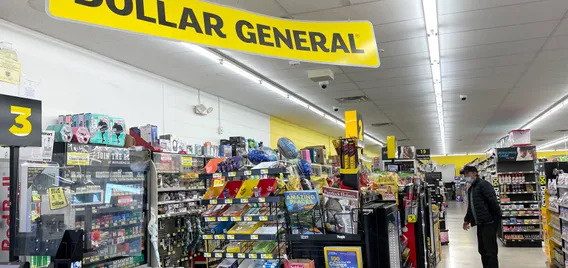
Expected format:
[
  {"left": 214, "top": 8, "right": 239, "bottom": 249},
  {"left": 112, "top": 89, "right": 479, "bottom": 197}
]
[{"left": 323, "top": 187, "right": 359, "bottom": 234}]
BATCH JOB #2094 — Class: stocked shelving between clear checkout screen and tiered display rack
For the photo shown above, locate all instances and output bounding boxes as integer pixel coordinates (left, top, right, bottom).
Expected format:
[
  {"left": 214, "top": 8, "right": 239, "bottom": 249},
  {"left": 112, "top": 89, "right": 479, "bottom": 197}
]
[{"left": 149, "top": 152, "right": 213, "bottom": 267}]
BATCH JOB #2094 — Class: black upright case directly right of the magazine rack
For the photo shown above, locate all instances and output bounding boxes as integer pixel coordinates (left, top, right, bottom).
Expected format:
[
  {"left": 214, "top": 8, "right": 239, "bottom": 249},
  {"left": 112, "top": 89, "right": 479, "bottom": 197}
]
[{"left": 363, "top": 201, "right": 401, "bottom": 268}]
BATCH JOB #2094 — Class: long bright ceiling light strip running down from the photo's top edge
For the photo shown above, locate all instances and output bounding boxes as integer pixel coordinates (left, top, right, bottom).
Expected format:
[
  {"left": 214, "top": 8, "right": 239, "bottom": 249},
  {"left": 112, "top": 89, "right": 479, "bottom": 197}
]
[{"left": 422, "top": 0, "right": 446, "bottom": 155}]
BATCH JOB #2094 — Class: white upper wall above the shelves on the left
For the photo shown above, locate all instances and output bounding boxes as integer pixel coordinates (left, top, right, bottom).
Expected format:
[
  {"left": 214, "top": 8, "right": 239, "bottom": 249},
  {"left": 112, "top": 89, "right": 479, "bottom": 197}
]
[{"left": 0, "top": 20, "right": 270, "bottom": 148}]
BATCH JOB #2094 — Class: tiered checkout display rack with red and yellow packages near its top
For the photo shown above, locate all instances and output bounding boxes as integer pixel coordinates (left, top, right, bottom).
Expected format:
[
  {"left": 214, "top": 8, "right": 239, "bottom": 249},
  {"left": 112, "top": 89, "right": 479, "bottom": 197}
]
[{"left": 200, "top": 168, "right": 288, "bottom": 265}]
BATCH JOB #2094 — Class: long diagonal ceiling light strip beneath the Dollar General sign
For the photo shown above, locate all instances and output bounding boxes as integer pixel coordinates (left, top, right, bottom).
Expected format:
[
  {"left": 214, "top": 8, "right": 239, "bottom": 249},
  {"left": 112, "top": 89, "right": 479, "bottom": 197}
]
[{"left": 181, "top": 42, "right": 384, "bottom": 146}]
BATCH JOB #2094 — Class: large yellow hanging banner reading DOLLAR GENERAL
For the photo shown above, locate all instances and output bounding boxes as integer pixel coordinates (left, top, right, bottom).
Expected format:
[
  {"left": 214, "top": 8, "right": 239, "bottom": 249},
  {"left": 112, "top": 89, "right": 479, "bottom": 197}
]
[{"left": 46, "top": 0, "right": 380, "bottom": 67}]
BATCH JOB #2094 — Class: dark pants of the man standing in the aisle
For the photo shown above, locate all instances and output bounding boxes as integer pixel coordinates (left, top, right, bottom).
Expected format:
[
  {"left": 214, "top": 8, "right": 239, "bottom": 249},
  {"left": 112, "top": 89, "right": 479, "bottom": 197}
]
[{"left": 477, "top": 223, "right": 499, "bottom": 268}]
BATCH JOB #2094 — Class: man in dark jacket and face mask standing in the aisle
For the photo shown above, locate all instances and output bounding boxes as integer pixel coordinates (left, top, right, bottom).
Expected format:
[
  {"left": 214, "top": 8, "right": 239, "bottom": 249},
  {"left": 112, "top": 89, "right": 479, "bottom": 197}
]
[{"left": 463, "top": 166, "right": 501, "bottom": 268}]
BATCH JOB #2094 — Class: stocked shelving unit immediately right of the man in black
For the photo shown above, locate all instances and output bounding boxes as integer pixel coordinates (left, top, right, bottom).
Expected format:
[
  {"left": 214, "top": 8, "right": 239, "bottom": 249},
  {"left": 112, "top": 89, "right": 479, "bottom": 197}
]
[{"left": 494, "top": 147, "right": 542, "bottom": 247}]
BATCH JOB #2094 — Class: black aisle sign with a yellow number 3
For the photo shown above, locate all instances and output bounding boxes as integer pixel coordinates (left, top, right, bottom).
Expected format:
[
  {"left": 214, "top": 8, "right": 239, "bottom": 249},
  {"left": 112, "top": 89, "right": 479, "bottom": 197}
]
[{"left": 0, "top": 94, "right": 41, "bottom": 147}]
